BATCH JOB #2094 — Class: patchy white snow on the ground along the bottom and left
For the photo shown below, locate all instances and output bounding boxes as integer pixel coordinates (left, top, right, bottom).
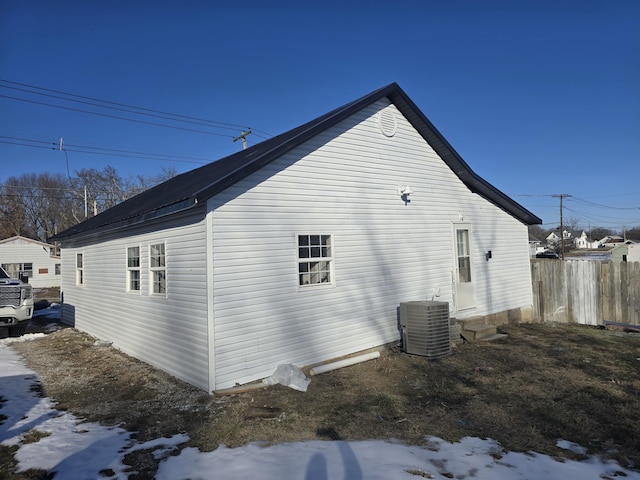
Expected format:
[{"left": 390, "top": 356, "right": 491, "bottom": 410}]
[{"left": 0, "top": 334, "right": 640, "bottom": 480}]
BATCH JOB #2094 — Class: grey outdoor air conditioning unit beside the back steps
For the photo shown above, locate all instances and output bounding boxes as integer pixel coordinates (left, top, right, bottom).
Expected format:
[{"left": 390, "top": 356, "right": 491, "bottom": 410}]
[{"left": 400, "top": 302, "right": 451, "bottom": 358}]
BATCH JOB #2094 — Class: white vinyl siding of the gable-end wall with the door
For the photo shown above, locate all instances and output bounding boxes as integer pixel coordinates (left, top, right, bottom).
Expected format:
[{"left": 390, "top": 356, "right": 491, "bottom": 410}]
[{"left": 209, "top": 101, "right": 532, "bottom": 388}]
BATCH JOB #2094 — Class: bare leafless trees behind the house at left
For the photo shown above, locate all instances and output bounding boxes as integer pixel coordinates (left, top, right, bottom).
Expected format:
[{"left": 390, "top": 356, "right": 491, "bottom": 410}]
[{"left": 0, "top": 166, "right": 176, "bottom": 242}]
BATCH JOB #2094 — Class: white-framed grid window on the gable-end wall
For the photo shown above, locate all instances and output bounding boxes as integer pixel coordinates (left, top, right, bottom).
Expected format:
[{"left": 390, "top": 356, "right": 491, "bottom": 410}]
[{"left": 298, "top": 235, "right": 333, "bottom": 286}]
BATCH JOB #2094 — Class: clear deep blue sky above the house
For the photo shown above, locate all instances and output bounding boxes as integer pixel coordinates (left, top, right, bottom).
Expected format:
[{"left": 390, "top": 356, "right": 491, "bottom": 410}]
[{"left": 0, "top": 0, "right": 640, "bottom": 229}]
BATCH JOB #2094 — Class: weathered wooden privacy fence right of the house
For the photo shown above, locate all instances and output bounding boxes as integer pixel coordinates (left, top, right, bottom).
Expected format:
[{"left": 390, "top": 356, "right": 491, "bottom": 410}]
[{"left": 531, "top": 259, "right": 640, "bottom": 325}]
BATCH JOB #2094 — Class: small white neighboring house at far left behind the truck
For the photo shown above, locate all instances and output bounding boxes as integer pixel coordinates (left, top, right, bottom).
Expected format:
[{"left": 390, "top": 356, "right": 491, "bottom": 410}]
[{"left": 0, "top": 236, "right": 61, "bottom": 288}]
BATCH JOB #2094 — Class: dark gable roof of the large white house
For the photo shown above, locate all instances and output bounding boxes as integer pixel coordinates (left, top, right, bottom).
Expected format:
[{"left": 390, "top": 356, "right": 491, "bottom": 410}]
[{"left": 52, "top": 83, "right": 542, "bottom": 240}]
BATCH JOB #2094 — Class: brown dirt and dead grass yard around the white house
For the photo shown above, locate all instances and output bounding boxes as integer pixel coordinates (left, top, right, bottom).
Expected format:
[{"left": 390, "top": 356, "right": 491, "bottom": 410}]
[{"left": 0, "top": 325, "right": 640, "bottom": 479}]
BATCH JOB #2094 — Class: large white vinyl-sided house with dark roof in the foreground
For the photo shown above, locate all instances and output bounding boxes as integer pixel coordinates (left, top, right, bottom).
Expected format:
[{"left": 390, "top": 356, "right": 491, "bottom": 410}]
[{"left": 54, "top": 84, "right": 541, "bottom": 391}]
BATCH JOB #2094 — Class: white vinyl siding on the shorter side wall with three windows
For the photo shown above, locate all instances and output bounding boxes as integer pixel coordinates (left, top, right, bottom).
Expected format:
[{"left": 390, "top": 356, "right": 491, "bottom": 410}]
[{"left": 62, "top": 216, "right": 209, "bottom": 390}]
